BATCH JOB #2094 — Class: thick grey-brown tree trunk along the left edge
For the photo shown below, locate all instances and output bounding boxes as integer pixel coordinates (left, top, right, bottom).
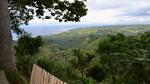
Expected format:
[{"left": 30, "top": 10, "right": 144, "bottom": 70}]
[{"left": 0, "top": 0, "right": 16, "bottom": 70}]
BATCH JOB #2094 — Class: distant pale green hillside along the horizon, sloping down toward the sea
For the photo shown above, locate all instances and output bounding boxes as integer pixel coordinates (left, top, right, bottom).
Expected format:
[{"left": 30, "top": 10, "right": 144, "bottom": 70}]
[{"left": 44, "top": 25, "right": 150, "bottom": 48}]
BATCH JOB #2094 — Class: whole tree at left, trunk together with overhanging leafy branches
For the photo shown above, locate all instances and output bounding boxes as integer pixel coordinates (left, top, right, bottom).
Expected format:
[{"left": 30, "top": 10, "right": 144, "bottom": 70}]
[{"left": 0, "top": 0, "right": 87, "bottom": 82}]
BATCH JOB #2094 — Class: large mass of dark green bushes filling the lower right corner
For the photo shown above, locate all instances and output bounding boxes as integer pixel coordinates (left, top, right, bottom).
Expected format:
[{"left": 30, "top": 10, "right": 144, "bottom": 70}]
[{"left": 96, "top": 32, "right": 150, "bottom": 84}]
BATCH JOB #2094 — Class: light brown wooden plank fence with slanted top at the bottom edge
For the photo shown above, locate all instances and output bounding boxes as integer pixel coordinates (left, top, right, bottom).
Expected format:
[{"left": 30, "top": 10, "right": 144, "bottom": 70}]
[{"left": 30, "top": 64, "right": 67, "bottom": 84}]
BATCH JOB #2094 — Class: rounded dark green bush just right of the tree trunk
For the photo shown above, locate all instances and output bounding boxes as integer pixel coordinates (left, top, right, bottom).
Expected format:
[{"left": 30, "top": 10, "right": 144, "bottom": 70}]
[{"left": 15, "top": 34, "right": 43, "bottom": 56}]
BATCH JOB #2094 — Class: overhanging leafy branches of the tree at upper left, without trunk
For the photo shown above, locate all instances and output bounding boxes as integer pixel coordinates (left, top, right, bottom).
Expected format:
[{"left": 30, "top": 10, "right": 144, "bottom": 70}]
[{"left": 9, "top": 0, "right": 87, "bottom": 34}]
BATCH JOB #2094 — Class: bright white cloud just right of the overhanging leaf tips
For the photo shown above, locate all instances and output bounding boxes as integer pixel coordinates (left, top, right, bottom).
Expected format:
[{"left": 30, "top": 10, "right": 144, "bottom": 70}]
[{"left": 81, "top": 10, "right": 122, "bottom": 24}]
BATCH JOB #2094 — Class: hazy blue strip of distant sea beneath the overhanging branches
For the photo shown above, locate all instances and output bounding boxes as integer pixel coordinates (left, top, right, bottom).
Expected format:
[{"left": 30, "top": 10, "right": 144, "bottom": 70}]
[{"left": 13, "top": 23, "right": 102, "bottom": 40}]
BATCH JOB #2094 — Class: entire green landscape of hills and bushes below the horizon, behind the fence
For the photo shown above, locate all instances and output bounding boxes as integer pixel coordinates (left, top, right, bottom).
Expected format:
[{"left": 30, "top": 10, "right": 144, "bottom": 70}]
[{"left": 16, "top": 25, "right": 150, "bottom": 84}]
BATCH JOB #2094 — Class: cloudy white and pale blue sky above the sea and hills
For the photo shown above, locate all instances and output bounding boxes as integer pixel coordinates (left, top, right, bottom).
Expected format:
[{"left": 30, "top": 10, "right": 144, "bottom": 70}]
[{"left": 30, "top": 0, "right": 150, "bottom": 25}]
